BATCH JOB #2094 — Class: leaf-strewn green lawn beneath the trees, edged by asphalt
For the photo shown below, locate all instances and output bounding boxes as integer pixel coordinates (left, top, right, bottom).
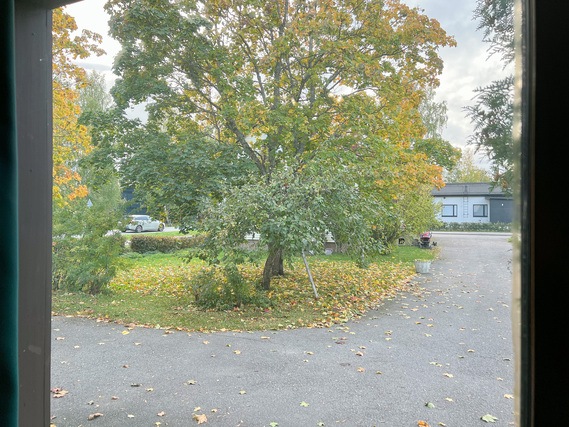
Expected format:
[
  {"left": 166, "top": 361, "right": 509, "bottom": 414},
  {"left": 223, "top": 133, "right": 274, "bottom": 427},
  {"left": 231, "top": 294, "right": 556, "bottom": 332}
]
[{"left": 52, "top": 246, "right": 438, "bottom": 332}]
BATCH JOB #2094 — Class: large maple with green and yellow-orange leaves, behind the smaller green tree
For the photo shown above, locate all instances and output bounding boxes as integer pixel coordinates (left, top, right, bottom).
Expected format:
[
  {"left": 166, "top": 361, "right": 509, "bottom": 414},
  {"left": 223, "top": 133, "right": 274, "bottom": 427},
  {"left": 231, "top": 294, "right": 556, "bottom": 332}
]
[{"left": 105, "top": 0, "right": 455, "bottom": 287}]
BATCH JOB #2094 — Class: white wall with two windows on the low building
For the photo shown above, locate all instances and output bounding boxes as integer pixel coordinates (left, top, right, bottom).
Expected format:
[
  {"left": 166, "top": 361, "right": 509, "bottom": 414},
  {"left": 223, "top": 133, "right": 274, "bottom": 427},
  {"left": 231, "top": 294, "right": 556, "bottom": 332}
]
[{"left": 435, "top": 196, "right": 490, "bottom": 222}]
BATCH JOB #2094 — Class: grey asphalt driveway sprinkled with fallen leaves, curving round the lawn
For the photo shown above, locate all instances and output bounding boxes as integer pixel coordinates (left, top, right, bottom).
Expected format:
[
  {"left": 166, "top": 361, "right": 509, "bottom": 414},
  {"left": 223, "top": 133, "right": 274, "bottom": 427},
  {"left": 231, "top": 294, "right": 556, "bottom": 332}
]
[{"left": 51, "top": 233, "right": 514, "bottom": 427}]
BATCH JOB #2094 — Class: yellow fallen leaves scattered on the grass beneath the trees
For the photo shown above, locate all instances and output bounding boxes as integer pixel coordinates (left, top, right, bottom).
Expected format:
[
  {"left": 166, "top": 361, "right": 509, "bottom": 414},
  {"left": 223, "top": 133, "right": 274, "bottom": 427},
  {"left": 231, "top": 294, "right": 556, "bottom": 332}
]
[{"left": 97, "top": 260, "right": 415, "bottom": 330}]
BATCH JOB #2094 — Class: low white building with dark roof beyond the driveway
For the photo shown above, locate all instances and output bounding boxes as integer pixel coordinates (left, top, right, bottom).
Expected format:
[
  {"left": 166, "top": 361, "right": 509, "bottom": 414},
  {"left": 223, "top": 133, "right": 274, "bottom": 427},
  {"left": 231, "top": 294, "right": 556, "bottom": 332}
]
[{"left": 431, "top": 182, "right": 514, "bottom": 224}]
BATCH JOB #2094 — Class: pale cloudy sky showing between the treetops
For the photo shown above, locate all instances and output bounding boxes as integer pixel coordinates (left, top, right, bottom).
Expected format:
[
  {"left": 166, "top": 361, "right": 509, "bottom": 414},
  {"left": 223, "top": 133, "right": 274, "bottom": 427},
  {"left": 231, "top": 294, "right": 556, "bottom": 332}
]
[{"left": 66, "top": 0, "right": 512, "bottom": 168}]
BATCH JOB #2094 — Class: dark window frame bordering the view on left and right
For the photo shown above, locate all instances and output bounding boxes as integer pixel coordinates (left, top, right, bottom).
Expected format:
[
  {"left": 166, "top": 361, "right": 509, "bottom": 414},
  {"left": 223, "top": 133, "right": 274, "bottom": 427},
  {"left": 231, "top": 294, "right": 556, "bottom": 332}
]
[{"left": 7, "top": 0, "right": 569, "bottom": 427}]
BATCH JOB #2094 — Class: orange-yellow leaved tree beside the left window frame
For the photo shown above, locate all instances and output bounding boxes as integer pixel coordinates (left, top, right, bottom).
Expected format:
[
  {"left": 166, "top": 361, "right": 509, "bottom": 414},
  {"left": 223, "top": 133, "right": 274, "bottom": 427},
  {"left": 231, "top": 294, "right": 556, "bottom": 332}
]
[{"left": 52, "top": 8, "right": 104, "bottom": 205}]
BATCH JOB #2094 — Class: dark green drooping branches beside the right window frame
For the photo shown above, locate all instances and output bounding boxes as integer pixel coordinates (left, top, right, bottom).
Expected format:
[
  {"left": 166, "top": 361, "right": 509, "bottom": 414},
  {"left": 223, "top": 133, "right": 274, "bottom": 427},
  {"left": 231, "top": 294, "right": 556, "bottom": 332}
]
[{"left": 465, "top": 0, "right": 514, "bottom": 190}]
